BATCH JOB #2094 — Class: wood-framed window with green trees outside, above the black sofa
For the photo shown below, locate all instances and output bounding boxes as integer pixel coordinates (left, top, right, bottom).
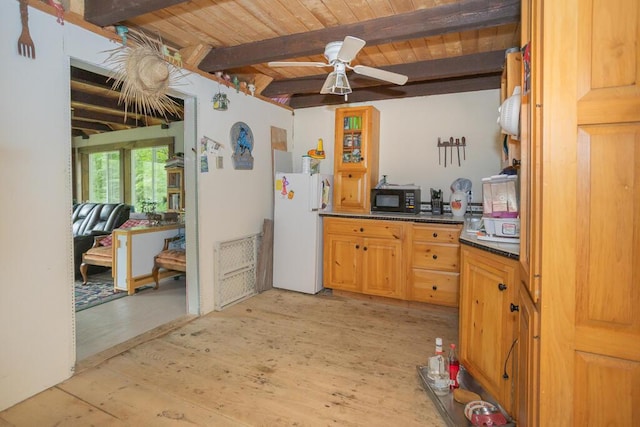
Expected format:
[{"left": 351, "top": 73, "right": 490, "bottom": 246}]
[{"left": 79, "top": 138, "right": 174, "bottom": 212}]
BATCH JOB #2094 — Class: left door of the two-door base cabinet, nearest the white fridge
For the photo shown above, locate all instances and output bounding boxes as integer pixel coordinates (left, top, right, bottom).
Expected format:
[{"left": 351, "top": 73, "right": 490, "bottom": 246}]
[{"left": 324, "top": 234, "right": 362, "bottom": 292}]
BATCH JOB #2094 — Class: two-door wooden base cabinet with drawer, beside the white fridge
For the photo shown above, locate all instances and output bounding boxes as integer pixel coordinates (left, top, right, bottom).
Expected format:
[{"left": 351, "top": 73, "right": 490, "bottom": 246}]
[{"left": 323, "top": 217, "right": 405, "bottom": 299}]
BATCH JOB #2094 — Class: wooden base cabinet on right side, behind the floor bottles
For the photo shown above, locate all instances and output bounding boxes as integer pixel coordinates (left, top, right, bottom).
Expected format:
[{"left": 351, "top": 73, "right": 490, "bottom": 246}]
[{"left": 459, "top": 245, "right": 519, "bottom": 413}]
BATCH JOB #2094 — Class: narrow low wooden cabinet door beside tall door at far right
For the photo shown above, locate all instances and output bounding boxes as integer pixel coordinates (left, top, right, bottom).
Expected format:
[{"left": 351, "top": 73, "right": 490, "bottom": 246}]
[{"left": 515, "top": 281, "right": 540, "bottom": 427}]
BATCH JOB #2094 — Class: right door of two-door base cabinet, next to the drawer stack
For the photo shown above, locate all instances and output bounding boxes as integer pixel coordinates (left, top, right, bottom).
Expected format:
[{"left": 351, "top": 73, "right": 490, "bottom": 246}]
[{"left": 361, "top": 239, "right": 404, "bottom": 298}]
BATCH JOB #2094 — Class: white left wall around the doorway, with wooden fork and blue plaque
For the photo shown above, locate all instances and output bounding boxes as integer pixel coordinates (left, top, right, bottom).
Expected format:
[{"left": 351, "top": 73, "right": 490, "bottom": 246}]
[{"left": 0, "top": 1, "right": 293, "bottom": 410}]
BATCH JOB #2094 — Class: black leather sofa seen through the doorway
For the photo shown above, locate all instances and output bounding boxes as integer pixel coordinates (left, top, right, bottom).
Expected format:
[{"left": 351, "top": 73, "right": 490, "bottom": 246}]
[{"left": 71, "top": 203, "right": 131, "bottom": 276}]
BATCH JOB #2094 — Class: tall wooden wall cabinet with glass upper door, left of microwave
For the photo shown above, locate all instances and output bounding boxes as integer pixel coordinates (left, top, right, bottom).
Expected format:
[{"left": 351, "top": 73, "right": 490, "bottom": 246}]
[{"left": 333, "top": 106, "right": 380, "bottom": 213}]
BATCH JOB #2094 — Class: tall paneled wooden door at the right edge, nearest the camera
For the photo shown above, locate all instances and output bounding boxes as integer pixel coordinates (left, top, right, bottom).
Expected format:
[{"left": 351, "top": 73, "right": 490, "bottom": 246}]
[{"left": 540, "top": 0, "right": 640, "bottom": 426}]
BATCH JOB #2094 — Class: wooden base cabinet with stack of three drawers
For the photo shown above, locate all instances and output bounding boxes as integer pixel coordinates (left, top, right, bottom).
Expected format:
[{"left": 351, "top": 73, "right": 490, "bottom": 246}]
[{"left": 407, "top": 224, "right": 461, "bottom": 307}]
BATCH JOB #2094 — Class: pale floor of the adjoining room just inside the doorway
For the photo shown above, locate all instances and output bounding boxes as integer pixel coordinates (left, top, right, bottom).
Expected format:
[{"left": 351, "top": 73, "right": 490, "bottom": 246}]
[{"left": 76, "top": 276, "right": 187, "bottom": 361}]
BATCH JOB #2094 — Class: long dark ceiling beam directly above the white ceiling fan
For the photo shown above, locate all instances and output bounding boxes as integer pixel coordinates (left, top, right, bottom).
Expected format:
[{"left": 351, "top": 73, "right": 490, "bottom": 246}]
[{"left": 200, "top": 0, "right": 520, "bottom": 72}]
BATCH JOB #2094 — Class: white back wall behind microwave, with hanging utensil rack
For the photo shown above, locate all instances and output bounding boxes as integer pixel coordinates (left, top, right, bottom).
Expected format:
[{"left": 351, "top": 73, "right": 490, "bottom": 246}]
[{"left": 293, "top": 89, "right": 502, "bottom": 203}]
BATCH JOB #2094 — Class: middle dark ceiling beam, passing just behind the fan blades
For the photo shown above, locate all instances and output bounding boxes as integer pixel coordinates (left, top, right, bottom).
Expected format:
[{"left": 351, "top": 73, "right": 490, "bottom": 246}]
[{"left": 262, "top": 50, "right": 504, "bottom": 96}]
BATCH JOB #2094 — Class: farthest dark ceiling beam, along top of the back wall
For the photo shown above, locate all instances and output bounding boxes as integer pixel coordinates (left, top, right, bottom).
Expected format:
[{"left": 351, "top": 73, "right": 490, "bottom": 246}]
[{"left": 289, "top": 73, "right": 501, "bottom": 108}]
